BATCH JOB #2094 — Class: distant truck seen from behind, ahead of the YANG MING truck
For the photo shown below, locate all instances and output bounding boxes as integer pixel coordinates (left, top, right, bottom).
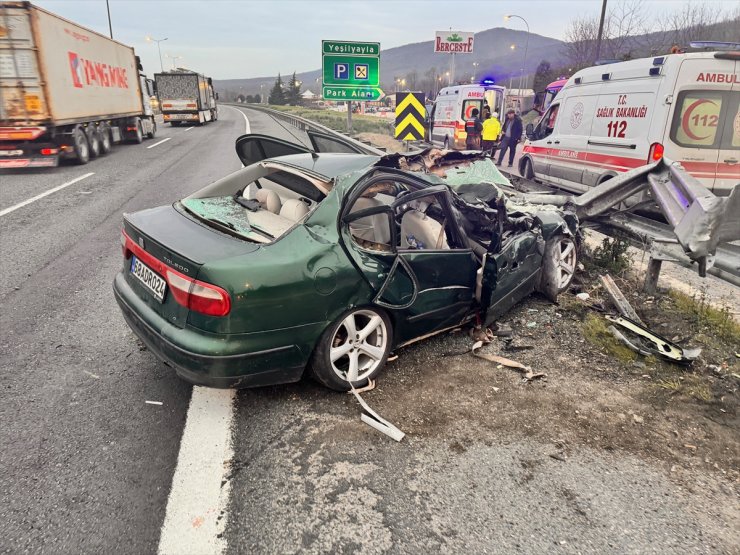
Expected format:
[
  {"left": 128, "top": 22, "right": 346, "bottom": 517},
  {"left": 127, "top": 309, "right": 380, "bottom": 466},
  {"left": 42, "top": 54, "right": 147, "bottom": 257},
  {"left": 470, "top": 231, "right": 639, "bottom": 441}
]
[{"left": 154, "top": 69, "right": 218, "bottom": 126}]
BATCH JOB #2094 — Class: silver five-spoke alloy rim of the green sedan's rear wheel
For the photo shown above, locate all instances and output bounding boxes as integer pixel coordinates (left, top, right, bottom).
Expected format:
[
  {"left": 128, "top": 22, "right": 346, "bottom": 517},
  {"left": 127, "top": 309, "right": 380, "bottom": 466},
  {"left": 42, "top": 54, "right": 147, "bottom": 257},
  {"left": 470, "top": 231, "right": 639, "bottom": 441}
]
[{"left": 329, "top": 310, "right": 389, "bottom": 383}]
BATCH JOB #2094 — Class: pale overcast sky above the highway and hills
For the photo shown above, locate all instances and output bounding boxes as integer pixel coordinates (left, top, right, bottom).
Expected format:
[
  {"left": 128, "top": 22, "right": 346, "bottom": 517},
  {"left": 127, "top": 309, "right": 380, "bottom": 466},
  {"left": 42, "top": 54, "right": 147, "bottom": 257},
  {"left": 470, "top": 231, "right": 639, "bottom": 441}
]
[{"left": 36, "top": 0, "right": 736, "bottom": 79}]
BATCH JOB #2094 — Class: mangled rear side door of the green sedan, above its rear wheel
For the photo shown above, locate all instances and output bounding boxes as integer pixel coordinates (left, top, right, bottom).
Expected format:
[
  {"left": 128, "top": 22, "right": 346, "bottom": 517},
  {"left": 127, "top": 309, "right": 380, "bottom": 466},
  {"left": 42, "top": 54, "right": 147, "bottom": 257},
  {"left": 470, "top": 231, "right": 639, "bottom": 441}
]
[{"left": 341, "top": 178, "right": 479, "bottom": 342}]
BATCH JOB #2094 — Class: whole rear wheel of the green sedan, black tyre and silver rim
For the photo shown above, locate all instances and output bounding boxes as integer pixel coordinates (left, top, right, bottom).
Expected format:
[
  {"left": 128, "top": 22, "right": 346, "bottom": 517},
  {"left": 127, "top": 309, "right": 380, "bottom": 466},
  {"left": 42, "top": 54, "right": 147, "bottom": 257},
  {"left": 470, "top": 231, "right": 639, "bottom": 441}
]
[{"left": 311, "top": 307, "right": 393, "bottom": 391}]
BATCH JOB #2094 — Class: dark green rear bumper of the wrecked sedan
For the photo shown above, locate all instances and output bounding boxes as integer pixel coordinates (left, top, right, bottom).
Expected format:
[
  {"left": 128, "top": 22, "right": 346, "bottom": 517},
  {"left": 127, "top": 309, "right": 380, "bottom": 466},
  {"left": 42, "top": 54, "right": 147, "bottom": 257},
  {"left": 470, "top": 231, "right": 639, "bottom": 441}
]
[{"left": 113, "top": 273, "right": 314, "bottom": 388}]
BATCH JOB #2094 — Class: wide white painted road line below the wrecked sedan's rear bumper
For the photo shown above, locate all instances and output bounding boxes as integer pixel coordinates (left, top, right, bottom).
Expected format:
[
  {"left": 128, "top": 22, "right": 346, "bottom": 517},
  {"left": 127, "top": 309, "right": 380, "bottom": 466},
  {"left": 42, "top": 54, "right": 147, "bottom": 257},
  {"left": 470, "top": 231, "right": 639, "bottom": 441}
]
[{"left": 158, "top": 386, "right": 236, "bottom": 555}]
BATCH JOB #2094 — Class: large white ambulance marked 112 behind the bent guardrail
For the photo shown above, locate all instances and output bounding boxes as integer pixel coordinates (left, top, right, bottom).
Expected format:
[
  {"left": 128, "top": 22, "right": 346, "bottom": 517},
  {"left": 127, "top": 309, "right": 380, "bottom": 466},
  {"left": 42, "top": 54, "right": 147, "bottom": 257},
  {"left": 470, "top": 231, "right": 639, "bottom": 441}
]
[{"left": 519, "top": 51, "right": 740, "bottom": 195}]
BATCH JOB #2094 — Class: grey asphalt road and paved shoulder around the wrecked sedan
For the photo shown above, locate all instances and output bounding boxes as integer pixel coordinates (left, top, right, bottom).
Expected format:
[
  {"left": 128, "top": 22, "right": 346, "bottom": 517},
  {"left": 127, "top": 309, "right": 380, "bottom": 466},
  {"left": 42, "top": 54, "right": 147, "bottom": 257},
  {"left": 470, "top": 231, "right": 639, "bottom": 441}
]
[{"left": 0, "top": 107, "right": 727, "bottom": 554}]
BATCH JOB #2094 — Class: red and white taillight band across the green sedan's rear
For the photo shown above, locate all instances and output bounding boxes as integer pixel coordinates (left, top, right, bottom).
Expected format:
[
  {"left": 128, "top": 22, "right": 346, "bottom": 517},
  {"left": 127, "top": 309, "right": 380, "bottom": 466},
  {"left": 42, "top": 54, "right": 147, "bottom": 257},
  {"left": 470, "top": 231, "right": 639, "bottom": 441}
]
[{"left": 121, "top": 231, "right": 231, "bottom": 316}]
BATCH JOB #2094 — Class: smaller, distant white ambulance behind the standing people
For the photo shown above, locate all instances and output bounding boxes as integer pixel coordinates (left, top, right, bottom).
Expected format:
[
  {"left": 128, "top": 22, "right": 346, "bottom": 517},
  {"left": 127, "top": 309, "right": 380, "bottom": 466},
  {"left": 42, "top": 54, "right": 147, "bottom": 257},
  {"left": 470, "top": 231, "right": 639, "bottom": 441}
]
[{"left": 429, "top": 81, "right": 506, "bottom": 149}]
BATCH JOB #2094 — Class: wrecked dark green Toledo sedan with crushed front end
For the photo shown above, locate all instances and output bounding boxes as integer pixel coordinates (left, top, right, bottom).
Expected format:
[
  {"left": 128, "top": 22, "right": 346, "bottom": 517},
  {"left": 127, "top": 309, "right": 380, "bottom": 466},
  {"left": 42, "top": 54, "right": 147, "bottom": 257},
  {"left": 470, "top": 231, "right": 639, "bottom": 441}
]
[{"left": 114, "top": 135, "right": 577, "bottom": 390}]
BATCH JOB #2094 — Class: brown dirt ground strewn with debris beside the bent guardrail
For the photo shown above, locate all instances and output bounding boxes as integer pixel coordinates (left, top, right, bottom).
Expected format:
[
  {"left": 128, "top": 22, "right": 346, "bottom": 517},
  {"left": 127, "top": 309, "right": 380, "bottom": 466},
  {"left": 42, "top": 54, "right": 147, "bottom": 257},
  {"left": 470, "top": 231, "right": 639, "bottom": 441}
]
[{"left": 356, "top": 253, "right": 740, "bottom": 544}]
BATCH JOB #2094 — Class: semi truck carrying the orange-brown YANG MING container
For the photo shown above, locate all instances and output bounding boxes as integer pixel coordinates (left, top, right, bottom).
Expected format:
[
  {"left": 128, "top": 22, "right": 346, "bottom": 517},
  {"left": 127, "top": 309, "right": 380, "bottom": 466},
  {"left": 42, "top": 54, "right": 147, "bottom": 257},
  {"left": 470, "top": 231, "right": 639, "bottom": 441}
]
[{"left": 0, "top": 0, "right": 157, "bottom": 168}]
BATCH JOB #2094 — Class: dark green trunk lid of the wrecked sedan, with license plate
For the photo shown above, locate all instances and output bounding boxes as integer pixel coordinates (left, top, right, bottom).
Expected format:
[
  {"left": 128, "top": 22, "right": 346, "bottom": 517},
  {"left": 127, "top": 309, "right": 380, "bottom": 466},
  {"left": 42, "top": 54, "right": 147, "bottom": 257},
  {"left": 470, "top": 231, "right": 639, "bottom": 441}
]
[{"left": 123, "top": 206, "right": 258, "bottom": 328}]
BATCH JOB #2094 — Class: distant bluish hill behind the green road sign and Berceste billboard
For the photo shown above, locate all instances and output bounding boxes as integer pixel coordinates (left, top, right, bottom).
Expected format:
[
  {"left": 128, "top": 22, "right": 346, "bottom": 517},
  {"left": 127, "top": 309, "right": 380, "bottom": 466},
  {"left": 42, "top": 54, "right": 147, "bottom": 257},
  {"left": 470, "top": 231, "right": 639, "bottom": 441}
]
[{"left": 214, "top": 27, "right": 567, "bottom": 99}]
